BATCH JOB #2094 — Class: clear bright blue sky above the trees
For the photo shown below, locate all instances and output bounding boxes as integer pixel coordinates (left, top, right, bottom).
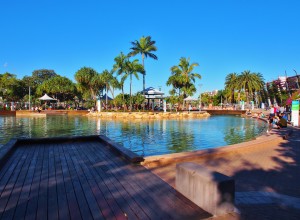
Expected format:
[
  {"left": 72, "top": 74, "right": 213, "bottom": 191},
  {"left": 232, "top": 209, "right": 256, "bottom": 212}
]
[{"left": 0, "top": 0, "right": 300, "bottom": 93}]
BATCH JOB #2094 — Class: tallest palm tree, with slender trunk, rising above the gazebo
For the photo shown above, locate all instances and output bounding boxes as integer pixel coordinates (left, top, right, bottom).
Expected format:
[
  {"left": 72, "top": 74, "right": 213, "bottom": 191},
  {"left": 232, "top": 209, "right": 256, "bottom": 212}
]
[{"left": 128, "top": 36, "right": 157, "bottom": 91}]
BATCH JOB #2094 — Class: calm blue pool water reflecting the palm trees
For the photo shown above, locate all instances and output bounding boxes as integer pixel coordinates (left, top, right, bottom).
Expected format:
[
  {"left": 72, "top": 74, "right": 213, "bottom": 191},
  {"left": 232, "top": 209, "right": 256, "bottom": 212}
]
[{"left": 0, "top": 115, "right": 268, "bottom": 156}]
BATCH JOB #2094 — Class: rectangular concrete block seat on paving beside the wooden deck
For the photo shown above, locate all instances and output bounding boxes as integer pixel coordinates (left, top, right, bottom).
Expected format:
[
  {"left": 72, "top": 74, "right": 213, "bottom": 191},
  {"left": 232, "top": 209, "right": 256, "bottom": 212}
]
[{"left": 176, "top": 162, "right": 235, "bottom": 216}]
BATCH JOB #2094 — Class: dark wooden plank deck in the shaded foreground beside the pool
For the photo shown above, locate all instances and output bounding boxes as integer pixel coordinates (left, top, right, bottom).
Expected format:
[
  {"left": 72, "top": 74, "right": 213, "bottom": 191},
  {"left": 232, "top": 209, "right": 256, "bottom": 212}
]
[{"left": 0, "top": 140, "right": 210, "bottom": 219}]
